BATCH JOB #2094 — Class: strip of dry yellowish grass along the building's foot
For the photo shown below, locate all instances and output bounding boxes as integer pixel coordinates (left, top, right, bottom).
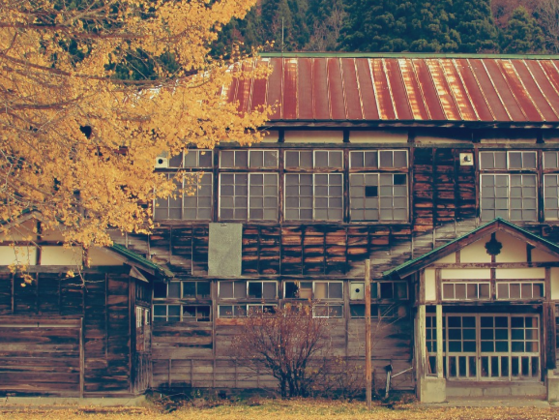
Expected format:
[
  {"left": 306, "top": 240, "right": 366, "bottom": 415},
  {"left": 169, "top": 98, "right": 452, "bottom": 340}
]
[{"left": 0, "top": 400, "right": 559, "bottom": 420}]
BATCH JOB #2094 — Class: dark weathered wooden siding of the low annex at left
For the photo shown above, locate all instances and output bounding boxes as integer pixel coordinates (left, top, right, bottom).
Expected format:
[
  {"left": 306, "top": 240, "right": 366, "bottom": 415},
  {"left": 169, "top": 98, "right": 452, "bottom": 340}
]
[{"left": 0, "top": 268, "right": 131, "bottom": 396}]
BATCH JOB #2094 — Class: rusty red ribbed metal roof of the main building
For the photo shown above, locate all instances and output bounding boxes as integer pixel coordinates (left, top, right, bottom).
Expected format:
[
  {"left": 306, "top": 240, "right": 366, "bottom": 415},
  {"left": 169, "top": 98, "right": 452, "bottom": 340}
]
[{"left": 226, "top": 54, "right": 559, "bottom": 125}]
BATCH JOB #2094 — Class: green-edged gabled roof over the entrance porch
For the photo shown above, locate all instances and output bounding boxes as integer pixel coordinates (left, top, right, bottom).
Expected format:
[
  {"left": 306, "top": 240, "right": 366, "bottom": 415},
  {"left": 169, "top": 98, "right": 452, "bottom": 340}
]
[{"left": 382, "top": 218, "right": 559, "bottom": 278}]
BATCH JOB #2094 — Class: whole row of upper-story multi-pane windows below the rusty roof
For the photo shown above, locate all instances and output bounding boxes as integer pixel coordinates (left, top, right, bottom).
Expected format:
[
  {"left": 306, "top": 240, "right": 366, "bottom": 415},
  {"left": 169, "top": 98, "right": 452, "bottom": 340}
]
[{"left": 154, "top": 149, "right": 559, "bottom": 222}]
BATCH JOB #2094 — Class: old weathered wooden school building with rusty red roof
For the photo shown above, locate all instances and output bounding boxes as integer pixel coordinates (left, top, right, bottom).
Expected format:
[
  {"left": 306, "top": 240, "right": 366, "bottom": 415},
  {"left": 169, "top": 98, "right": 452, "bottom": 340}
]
[{"left": 0, "top": 53, "right": 559, "bottom": 402}]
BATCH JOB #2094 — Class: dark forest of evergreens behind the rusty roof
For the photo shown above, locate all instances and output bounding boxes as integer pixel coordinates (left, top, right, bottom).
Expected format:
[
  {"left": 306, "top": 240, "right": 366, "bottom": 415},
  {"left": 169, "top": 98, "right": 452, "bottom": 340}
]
[{"left": 213, "top": 0, "right": 559, "bottom": 56}]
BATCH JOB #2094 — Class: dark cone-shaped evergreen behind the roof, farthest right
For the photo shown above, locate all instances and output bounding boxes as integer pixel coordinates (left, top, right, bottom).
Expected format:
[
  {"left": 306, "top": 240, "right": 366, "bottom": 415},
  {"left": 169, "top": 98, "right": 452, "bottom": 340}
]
[{"left": 501, "top": 6, "right": 545, "bottom": 54}]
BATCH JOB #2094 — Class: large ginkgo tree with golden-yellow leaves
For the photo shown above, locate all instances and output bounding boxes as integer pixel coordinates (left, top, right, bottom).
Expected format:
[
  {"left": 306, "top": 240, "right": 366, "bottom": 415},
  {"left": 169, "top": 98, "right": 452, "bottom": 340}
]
[{"left": 0, "top": 0, "right": 269, "bottom": 248}]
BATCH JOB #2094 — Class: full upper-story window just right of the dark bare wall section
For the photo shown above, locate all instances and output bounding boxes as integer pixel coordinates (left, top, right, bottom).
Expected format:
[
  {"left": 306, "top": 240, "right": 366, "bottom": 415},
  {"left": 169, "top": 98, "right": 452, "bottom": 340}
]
[{"left": 480, "top": 151, "right": 538, "bottom": 221}]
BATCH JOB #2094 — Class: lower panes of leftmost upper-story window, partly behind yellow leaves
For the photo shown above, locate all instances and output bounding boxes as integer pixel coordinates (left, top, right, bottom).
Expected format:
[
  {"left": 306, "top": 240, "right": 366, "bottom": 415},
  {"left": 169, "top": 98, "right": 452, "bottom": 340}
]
[{"left": 154, "top": 173, "right": 213, "bottom": 220}]
